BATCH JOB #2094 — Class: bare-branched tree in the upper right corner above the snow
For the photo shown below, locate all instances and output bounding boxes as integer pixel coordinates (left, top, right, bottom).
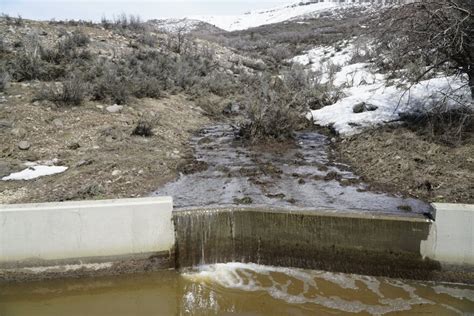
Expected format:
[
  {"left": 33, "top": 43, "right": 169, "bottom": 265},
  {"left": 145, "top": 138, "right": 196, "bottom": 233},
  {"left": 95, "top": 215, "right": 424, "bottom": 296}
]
[{"left": 376, "top": 0, "right": 474, "bottom": 97}]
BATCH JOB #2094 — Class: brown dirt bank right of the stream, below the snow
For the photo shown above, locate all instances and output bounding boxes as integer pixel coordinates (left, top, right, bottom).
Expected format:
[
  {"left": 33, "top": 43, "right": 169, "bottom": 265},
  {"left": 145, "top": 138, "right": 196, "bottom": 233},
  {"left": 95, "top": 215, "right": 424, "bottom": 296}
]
[{"left": 334, "top": 127, "right": 474, "bottom": 204}]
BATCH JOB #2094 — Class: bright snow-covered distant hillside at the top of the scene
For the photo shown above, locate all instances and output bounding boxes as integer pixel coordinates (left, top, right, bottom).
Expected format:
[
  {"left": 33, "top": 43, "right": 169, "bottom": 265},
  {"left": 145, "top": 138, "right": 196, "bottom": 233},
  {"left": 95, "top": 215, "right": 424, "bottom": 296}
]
[{"left": 192, "top": 1, "right": 347, "bottom": 31}]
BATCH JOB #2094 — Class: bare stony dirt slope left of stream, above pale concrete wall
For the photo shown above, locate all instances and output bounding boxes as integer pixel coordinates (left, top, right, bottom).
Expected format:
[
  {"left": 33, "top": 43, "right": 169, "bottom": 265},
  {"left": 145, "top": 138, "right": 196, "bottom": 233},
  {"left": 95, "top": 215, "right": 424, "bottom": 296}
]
[{"left": 0, "top": 83, "right": 209, "bottom": 203}]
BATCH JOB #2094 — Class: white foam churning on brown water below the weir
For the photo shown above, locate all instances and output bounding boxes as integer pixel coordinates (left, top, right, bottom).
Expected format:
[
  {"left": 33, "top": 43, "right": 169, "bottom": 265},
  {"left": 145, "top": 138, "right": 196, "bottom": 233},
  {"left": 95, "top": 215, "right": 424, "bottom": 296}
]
[{"left": 182, "top": 263, "right": 442, "bottom": 315}]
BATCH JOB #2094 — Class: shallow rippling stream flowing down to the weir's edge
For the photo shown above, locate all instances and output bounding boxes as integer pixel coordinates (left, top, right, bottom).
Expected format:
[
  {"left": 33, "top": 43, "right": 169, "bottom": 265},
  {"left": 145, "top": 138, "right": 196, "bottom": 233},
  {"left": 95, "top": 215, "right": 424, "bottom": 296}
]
[{"left": 153, "top": 124, "right": 430, "bottom": 216}]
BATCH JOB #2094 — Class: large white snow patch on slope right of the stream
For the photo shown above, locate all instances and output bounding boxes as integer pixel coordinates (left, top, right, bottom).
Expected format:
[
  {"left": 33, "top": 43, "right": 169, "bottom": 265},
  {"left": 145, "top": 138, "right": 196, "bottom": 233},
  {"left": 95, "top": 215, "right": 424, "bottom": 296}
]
[{"left": 291, "top": 41, "right": 472, "bottom": 136}]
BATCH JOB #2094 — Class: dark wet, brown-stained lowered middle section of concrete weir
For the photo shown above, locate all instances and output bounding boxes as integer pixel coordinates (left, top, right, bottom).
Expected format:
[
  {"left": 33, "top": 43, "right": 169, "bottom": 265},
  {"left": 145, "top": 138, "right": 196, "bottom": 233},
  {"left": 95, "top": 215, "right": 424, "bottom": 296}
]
[{"left": 174, "top": 208, "right": 440, "bottom": 279}]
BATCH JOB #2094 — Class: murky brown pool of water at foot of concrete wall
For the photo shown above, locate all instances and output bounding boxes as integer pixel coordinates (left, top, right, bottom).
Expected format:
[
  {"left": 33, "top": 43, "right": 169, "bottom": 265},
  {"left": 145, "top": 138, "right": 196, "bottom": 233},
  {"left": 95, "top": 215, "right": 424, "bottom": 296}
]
[{"left": 0, "top": 263, "right": 474, "bottom": 316}]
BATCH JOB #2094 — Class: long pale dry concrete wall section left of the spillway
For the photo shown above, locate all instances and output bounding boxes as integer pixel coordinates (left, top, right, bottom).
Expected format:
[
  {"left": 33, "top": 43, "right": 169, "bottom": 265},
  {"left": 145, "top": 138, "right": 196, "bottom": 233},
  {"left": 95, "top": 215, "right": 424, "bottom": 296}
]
[{"left": 0, "top": 197, "right": 175, "bottom": 269}]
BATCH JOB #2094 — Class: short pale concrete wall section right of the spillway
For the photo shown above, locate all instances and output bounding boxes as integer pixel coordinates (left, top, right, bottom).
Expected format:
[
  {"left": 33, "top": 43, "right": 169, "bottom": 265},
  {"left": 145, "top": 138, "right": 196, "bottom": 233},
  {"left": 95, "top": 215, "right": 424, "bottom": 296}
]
[{"left": 421, "top": 203, "right": 474, "bottom": 271}]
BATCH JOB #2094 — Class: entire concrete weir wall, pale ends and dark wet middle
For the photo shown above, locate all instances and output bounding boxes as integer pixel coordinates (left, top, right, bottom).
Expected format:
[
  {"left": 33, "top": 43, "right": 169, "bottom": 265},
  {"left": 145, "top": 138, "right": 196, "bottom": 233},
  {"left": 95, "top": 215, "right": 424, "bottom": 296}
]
[{"left": 0, "top": 197, "right": 474, "bottom": 283}]
